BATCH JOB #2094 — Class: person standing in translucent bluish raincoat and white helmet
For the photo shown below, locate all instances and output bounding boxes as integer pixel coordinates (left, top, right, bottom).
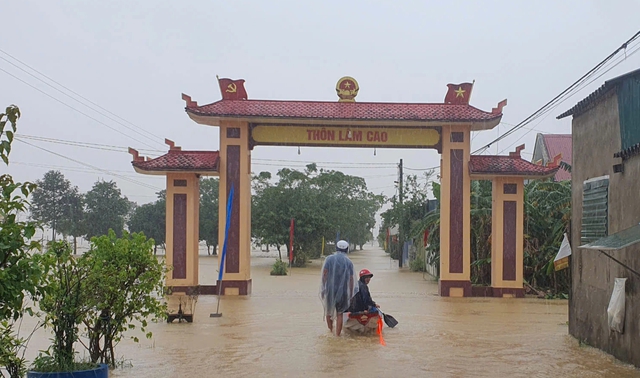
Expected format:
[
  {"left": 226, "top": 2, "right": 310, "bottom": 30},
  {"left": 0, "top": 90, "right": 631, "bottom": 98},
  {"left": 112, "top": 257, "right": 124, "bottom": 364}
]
[{"left": 320, "top": 240, "right": 359, "bottom": 336}]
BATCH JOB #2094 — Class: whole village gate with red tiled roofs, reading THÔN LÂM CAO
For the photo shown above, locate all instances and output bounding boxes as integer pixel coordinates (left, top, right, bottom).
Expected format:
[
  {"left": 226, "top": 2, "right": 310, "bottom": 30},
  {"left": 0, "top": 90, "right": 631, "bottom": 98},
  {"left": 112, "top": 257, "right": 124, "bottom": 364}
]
[{"left": 127, "top": 77, "right": 558, "bottom": 296}]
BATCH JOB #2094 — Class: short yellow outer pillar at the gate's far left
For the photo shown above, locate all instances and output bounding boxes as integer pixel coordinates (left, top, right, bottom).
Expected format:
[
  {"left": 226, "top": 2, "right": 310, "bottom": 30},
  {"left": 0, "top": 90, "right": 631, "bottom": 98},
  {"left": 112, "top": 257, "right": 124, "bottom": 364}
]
[{"left": 166, "top": 173, "right": 200, "bottom": 287}]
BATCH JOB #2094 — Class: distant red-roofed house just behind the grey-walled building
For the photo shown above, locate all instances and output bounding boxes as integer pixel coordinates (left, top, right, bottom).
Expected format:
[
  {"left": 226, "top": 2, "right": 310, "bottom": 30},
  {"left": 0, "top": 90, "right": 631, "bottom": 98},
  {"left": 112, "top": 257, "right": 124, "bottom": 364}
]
[{"left": 531, "top": 134, "right": 572, "bottom": 181}]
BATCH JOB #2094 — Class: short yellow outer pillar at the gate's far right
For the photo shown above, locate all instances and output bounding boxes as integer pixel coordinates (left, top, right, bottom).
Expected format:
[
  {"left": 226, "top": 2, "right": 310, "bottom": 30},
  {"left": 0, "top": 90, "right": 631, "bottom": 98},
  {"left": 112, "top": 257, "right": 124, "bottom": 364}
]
[{"left": 491, "top": 177, "right": 524, "bottom": 297}]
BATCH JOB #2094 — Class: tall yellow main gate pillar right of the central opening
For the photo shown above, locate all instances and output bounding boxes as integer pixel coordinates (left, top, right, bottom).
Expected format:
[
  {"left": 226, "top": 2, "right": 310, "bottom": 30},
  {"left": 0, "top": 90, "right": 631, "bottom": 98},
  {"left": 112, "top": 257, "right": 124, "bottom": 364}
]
[{"left": 439, "top": 125, "right": 471, "bottom": 297}]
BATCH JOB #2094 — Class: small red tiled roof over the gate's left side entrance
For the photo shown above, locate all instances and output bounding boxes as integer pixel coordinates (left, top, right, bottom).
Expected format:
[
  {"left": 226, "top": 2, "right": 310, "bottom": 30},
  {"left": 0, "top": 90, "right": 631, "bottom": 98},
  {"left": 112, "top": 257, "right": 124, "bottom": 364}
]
[{"left": 131, "top": 149, "right": 220, "bottom": 172}]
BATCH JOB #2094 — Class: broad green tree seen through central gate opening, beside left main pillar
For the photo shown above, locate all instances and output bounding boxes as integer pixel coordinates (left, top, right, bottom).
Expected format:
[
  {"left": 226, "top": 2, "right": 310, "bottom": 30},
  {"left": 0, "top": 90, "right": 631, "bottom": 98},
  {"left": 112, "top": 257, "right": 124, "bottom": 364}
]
[{"left": 252, "top": 164, "right": 382, "bottom": 265}]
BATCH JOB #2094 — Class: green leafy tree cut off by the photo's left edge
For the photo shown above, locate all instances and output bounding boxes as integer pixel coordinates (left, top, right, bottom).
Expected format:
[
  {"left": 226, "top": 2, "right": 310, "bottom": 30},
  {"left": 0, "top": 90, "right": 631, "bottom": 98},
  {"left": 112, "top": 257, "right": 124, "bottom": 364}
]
[{"left": 0, "top": 105, "right": 47, "bottom": 378}]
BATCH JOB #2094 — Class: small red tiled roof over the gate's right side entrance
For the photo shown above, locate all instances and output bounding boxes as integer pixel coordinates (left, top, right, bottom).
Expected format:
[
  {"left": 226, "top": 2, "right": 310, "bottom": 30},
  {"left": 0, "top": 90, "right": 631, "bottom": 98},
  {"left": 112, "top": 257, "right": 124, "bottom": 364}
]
[{"left": 469, "top": 155, "right": 558, "bottom": 178}]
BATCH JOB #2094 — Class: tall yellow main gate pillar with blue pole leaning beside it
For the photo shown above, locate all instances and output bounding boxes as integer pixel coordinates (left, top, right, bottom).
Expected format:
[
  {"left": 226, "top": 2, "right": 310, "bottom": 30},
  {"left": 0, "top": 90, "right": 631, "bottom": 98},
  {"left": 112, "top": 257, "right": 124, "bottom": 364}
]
[{"left": 218, "top": 121, "right": 251, "bottom": 295}]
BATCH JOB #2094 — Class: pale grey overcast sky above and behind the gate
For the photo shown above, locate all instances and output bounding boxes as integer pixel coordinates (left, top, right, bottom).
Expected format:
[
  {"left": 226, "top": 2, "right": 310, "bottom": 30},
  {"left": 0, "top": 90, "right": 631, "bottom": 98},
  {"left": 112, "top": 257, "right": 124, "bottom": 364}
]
[{"left": 0, "top": 0, "right": 640, "bottom": 217}]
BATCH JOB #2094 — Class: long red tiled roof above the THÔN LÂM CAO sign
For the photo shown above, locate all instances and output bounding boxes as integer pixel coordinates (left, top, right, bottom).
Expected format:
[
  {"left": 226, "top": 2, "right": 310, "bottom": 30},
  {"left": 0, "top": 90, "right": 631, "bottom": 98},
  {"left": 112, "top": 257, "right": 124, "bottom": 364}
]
[{"left": 186, "top": 96, "right": 504, "bottom": 122}]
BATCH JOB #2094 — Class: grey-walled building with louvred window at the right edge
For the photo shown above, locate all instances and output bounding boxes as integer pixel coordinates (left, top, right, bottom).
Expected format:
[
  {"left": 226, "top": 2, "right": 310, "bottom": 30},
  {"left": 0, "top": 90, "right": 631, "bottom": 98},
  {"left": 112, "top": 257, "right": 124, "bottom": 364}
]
[{"left": 558, "top": 66, "right": 640, "bottom": 367}]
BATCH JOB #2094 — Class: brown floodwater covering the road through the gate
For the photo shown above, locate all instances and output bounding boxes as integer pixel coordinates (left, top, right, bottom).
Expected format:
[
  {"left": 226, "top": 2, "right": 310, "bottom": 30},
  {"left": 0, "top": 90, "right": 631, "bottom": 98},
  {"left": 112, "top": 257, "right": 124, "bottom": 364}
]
[{"left": 15, "top": 246, "right": 640, "bottom": 378}]
